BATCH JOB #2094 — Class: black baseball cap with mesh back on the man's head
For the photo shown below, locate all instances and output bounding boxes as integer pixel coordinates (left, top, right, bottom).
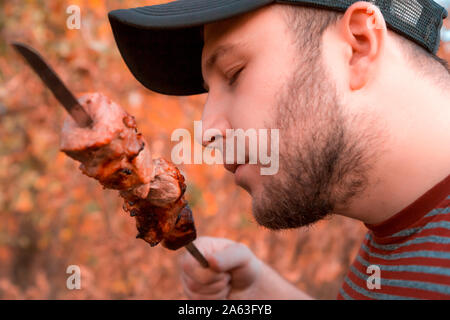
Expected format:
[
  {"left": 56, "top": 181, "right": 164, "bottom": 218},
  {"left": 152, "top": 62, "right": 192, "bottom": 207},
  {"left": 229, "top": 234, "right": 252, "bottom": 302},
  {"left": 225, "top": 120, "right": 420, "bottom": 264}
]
[{"left": 109, "top": 0, "right": 447, "bottom": 96}]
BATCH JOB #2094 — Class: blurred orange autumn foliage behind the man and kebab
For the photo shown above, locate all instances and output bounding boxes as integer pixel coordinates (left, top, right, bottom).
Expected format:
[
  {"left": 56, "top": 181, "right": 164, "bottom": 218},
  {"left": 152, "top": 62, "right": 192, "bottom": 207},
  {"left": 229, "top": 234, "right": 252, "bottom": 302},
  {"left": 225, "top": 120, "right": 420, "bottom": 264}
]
[{"left": 0, "top": 0, "right": 450, "bottom": 299}]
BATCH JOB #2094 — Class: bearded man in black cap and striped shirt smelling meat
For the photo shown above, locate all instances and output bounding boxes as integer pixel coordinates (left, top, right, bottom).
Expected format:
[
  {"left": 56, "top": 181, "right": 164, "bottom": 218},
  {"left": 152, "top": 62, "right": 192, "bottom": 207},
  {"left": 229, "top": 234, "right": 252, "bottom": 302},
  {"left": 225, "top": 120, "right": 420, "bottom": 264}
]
[{"left": 110, "top": 0, "right": 450, "bottom": 299}]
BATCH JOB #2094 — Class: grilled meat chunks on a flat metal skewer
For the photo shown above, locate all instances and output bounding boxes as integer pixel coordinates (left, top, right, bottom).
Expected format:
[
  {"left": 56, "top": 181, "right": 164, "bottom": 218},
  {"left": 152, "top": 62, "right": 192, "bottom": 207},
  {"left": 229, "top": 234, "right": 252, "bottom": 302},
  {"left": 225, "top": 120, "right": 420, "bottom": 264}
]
[{"left": 12, "top": 42, "right": 209, "bottom": 268}]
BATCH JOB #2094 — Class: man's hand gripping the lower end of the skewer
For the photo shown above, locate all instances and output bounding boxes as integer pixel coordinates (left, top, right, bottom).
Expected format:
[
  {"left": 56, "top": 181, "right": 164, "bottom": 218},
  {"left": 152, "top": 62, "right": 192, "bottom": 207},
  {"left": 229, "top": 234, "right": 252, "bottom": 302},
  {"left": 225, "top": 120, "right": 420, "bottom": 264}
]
[{"left": 180, "top": 237, "right": 263, "bottom": 300}]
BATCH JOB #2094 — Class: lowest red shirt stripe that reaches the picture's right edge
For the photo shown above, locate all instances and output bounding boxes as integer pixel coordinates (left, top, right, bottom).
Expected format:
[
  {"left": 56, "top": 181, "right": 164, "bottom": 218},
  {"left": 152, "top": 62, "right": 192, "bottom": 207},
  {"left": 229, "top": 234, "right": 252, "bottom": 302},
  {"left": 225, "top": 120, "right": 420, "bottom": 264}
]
[{"left": 348, "top": 270, "right": 450, "bottom": 300}]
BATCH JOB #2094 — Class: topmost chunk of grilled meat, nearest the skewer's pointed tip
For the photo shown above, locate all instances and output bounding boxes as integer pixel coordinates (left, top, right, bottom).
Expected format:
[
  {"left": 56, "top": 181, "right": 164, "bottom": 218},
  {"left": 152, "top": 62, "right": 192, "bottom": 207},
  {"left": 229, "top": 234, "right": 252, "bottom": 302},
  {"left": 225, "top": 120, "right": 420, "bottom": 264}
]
[{"left": 61, "top": 94, "right": 153, "bottom": 190}]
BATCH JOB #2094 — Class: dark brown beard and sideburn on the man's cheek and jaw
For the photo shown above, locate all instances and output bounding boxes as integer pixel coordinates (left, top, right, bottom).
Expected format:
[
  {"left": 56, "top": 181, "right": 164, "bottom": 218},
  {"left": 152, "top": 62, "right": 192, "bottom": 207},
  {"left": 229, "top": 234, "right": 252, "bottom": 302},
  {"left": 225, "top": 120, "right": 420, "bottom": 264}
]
[{"left": 252, "top": 53, "right": 378, "bottom": 230}]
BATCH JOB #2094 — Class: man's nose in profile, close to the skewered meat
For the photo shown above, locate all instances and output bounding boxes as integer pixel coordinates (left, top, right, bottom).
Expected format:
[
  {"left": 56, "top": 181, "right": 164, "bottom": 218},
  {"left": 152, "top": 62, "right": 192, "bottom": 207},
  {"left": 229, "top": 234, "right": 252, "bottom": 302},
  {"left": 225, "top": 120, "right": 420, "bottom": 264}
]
[{"left": 201, "top": 98, "right": 231, "bottom": 147}]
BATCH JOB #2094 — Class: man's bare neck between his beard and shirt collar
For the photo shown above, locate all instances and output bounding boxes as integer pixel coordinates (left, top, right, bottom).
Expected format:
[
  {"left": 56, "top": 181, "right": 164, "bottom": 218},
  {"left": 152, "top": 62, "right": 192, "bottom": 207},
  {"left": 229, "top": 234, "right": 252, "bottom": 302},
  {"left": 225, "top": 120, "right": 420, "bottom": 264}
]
[{"left": 340, "top": 72, "right": 450, "bottom": 224}]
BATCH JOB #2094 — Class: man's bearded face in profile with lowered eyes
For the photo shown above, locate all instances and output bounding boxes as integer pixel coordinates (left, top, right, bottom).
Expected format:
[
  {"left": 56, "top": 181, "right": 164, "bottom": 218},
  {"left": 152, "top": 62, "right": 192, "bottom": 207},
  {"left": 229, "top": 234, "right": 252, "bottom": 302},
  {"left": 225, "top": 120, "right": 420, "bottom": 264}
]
[{"left": 202, "top": 5, "right": 365, "bottom": 229}]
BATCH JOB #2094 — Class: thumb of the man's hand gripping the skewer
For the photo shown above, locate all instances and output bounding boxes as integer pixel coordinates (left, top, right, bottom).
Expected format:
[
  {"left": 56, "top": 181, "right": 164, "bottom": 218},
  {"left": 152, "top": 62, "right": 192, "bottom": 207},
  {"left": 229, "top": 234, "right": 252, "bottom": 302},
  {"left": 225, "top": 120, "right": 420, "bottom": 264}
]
[{"left": 208, "top": 243, "right": 252, "bottom": 272}]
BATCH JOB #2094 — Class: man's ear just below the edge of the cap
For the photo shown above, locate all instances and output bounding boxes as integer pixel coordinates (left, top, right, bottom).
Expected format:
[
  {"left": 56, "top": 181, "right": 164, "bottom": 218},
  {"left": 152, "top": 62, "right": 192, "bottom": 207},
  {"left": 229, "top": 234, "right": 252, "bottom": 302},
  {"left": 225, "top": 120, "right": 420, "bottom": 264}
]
[{"left": 340, "top": 1, "right": 387, "bottom": 90}]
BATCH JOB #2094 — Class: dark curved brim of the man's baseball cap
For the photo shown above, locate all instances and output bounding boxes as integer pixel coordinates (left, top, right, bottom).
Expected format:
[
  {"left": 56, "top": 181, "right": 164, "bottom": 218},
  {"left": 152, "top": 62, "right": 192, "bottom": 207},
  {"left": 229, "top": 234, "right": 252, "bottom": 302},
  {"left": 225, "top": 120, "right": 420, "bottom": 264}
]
[{"left": 109, "top": 0, "right": 274, "bottom": 96}]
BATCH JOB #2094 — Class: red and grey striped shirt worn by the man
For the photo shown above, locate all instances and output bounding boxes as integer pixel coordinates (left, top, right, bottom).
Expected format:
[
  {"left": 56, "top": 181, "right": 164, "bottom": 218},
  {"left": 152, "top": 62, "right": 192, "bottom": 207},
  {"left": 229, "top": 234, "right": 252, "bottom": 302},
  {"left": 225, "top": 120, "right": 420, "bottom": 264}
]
[{"left": 337, "top": 175, "right": 450, "bottom": 299}]
